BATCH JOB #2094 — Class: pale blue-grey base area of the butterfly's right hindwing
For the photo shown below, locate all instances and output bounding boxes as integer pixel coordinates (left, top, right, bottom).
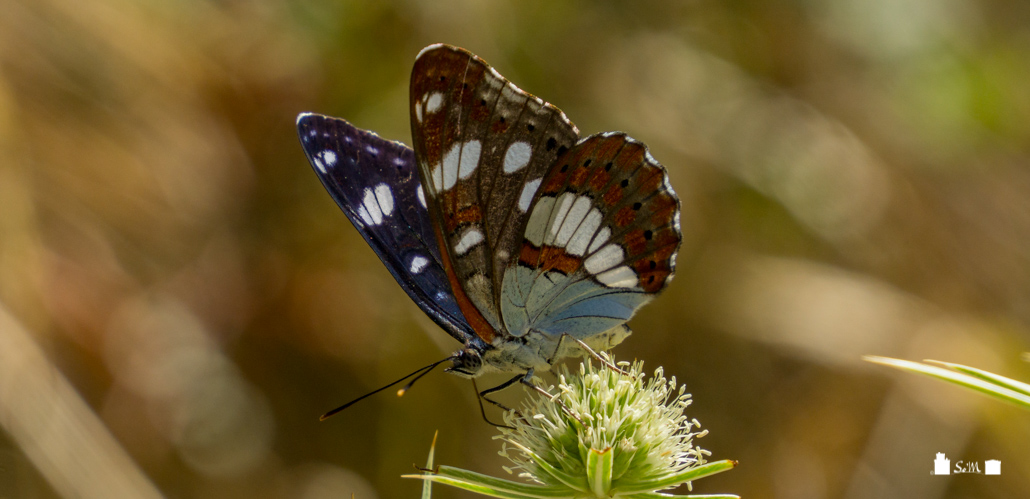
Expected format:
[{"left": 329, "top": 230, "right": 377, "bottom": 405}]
[{"left": 501, "top": 265, "right": 652, "bottom": 340}]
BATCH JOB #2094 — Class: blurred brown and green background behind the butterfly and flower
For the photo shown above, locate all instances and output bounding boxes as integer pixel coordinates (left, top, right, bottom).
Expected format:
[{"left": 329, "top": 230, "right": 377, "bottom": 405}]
[{"left": 0, "top": 0, "right": 1030, "bottom": 499}]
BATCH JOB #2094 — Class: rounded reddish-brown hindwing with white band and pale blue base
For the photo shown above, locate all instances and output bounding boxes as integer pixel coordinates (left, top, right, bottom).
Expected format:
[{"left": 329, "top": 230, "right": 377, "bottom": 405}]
[{"left": 502, "top": 133, "right": 682, "bottom": 338}]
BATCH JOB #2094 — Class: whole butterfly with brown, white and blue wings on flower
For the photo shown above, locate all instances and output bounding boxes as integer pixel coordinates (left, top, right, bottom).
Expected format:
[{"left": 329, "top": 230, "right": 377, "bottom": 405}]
[{"left": 297, "top": 44, "right": 682, "bottom": 385}]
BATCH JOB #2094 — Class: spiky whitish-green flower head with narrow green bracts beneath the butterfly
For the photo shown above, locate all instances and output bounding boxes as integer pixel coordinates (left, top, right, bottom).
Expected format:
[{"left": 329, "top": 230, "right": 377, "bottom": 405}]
[{"left": 409, "top": 354, "right": 736, "bottom": 498}]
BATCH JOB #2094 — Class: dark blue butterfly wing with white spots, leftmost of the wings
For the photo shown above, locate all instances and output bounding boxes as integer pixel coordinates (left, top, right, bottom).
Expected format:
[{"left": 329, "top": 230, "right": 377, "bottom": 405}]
[{"left": 297, "top": 112, "right": 479, "bottom": 343}]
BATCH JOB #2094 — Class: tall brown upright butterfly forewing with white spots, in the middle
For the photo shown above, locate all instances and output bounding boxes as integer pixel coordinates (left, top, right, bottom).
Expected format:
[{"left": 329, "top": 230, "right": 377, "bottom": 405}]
[{"left": 411, "top": 45, "right": 579, "bottom": 341}]
